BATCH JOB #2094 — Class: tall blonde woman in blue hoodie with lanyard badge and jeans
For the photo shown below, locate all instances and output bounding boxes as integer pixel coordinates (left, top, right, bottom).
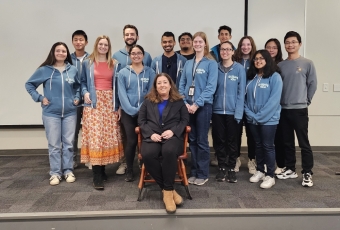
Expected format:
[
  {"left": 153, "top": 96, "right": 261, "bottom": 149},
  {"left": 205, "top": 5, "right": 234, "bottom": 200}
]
[{"left": 179, "top": 32, "right": 218, "bottom": 185}]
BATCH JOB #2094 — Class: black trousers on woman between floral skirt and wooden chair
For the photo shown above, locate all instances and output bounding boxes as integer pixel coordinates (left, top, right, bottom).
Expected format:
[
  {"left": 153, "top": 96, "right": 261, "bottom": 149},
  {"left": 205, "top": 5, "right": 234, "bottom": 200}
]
[{"left": 120, "top": 110, "right": 138, "bottom": 170}]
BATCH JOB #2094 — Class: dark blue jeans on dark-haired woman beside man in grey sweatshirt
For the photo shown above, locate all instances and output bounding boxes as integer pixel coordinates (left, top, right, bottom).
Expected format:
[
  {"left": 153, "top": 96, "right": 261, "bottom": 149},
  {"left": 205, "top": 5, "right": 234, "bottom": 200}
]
[{"left": 249, "top": 124, "right": 277, "bottom": 177}]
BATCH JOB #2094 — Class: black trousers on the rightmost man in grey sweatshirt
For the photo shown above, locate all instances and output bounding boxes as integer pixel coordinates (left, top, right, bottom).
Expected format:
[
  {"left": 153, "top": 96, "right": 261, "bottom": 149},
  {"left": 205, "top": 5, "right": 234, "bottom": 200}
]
[{"left": 280, "top": 108, "right": 314, "bottom": 173}]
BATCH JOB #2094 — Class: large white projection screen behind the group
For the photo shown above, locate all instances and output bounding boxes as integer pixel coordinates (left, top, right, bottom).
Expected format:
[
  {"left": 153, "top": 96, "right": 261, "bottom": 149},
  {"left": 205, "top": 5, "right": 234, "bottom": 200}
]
[{"left": 0, "top": 0, "right": 244, "bottom": 125}]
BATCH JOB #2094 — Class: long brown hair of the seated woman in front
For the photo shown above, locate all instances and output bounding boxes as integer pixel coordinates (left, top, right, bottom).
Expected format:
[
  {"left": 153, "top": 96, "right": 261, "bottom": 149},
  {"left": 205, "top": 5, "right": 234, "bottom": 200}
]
[{"left": 145, "top": 73, "right": 183, "bottom": 103}]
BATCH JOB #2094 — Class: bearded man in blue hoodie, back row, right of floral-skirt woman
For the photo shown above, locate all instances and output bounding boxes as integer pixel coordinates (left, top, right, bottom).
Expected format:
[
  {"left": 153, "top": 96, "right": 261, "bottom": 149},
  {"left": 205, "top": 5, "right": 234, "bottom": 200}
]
[{"left": 112, "top": 24, "right": 152, "bottom": 69}]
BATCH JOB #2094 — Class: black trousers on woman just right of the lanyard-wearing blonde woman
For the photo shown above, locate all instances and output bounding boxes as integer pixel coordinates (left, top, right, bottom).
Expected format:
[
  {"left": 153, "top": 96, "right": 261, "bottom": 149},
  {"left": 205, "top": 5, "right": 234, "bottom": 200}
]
[{"left": 212, "top": 113, "right": 242, "bottom": 169}]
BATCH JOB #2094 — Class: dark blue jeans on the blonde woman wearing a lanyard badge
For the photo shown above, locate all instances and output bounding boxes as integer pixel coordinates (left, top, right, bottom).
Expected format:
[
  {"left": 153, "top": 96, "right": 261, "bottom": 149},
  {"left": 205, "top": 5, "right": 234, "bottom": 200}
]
[{"left": 189, "top": 104, "right": 212, "bottom": 179}]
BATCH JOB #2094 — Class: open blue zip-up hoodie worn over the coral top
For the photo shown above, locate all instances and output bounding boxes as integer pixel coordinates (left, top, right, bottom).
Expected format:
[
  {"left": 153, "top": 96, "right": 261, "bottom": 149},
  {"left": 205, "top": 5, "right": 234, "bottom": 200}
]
[{"left": 81, "top": 59, "right": 121, "bottom": 111}]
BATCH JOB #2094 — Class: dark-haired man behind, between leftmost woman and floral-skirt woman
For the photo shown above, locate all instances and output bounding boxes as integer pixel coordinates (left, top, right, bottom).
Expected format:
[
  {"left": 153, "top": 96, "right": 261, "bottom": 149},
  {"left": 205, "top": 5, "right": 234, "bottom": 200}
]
[{"left": 71, "top": 30, "right": 89, "bottom": 168}]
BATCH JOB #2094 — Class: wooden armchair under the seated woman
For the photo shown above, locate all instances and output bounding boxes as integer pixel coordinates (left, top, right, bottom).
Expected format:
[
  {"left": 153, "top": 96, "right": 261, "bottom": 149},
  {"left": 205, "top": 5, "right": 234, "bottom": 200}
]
[{"left": 135, "top": 126, "right": 192, "bottom": 201}]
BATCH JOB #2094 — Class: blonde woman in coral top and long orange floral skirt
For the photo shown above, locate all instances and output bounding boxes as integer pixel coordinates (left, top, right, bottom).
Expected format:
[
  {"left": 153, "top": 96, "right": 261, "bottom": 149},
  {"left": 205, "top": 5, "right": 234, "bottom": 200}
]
[{"left": 81, "top": 35, "right": 123, "bottom": 189}]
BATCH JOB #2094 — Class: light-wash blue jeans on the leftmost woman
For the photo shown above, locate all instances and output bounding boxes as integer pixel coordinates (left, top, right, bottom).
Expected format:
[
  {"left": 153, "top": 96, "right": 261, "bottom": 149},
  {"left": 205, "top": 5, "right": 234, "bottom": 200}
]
[{"left": 42, "top": 114, "right": 77, "bottom": 176}]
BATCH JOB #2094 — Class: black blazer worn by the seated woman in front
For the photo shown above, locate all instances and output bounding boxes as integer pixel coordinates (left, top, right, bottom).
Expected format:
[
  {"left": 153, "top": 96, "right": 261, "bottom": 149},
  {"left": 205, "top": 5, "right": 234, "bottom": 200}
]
[{"left": 138, "top": 99, "right": 189, "bottom": 142}]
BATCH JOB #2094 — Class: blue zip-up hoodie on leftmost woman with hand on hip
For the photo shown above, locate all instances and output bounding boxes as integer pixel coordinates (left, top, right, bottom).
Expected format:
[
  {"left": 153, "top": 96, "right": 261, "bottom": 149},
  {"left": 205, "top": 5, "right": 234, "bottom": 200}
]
[{"left": 25, "top": 63, "right": 80, "bottom": 117}]
